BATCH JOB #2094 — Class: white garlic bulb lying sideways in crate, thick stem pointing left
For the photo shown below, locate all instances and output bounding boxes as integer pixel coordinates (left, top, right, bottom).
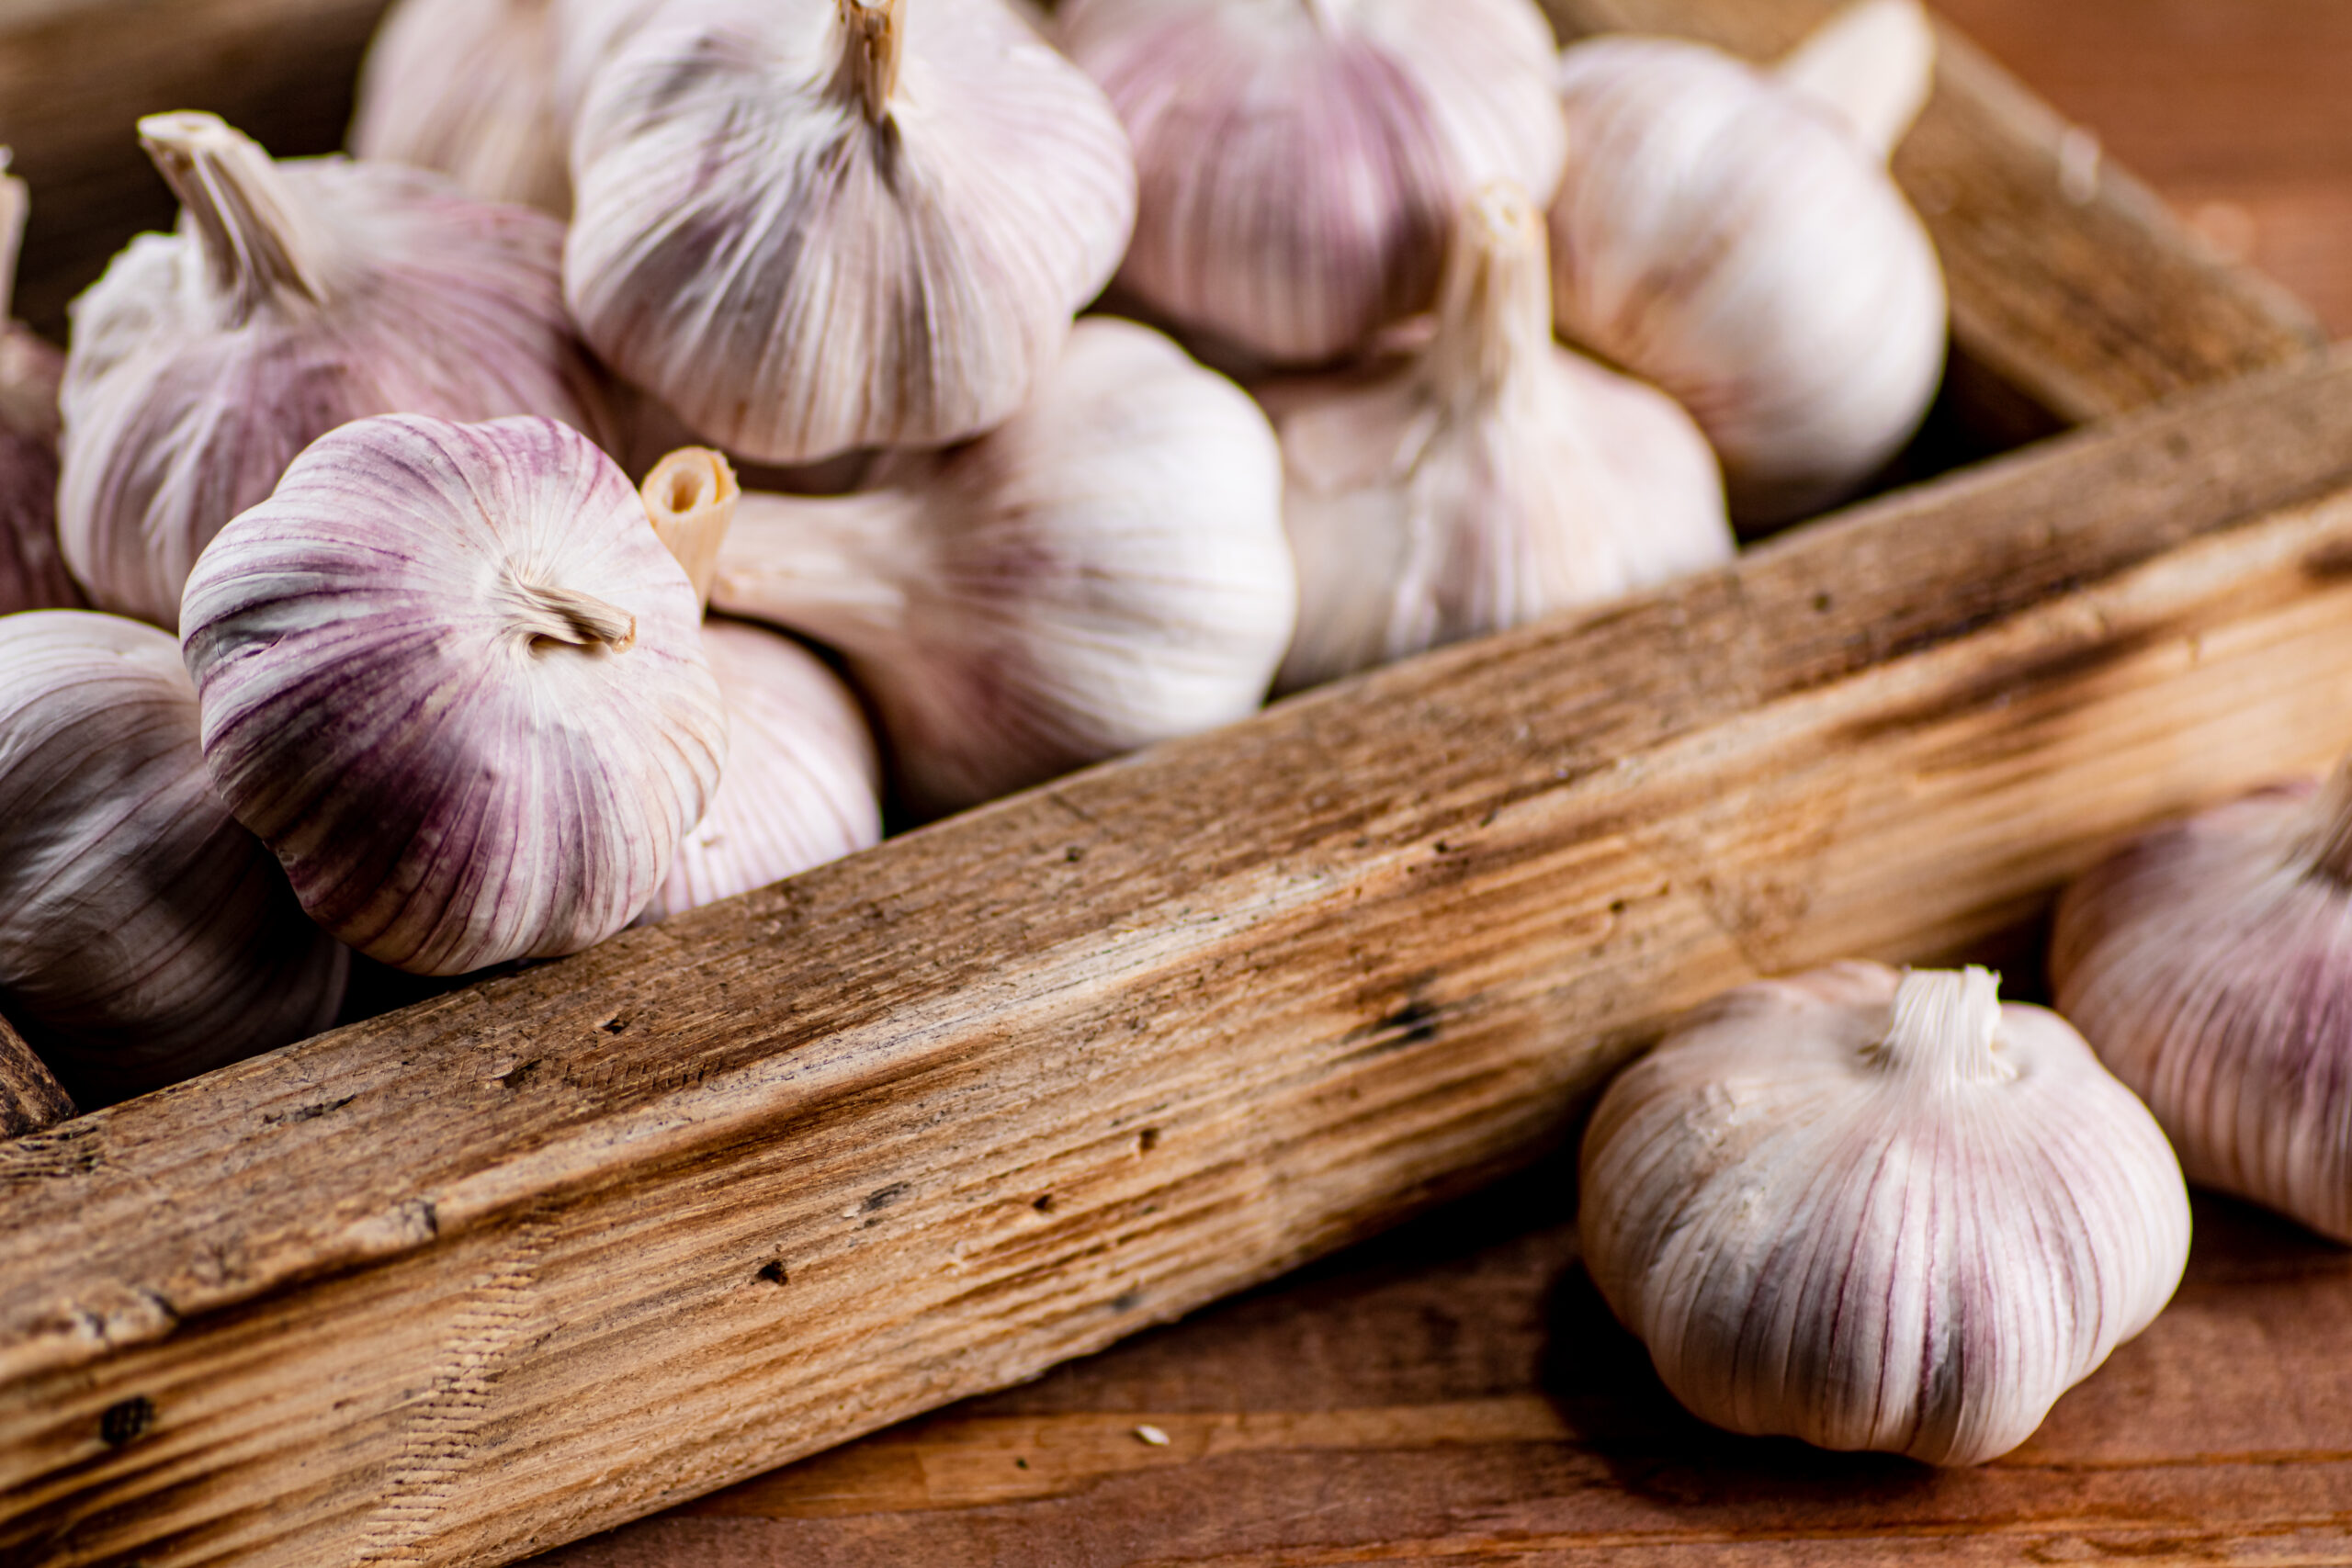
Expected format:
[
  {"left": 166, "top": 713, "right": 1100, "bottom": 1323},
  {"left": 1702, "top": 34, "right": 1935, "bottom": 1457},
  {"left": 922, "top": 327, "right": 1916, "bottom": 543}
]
[{"left": 710, "top": 320, "right": 1296, "bottom": 813}]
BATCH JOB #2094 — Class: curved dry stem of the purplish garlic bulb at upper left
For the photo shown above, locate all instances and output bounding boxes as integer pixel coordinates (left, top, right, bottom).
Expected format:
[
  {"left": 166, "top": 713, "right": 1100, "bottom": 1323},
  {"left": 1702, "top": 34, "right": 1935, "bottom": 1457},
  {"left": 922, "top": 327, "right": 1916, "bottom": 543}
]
[{"left": 139, "top": 113, "right": 327, "bottom": 324}]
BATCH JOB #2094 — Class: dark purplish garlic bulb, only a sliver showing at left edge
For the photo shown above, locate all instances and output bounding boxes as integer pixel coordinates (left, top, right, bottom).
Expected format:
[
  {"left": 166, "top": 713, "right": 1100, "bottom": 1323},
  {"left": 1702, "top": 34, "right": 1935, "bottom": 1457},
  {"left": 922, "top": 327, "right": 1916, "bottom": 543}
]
[{"left": 0, "top": 148, "right": 83, "bottom": 616}]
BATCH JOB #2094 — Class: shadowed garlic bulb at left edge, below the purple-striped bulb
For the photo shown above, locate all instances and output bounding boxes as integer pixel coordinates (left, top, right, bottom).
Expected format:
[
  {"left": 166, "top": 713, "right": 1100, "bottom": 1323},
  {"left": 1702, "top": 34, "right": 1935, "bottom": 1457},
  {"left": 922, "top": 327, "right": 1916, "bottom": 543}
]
[{"left": 0, "top": 609, "right": 350, "bottom": 1105}]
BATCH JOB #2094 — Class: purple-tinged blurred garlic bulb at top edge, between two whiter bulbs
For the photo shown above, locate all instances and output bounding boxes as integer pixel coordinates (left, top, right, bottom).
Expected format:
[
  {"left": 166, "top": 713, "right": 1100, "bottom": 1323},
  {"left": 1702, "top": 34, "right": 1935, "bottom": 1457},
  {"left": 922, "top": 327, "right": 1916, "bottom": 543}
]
[{"left": 1061, "top": 0, "right": 1566, "bottom": 365}]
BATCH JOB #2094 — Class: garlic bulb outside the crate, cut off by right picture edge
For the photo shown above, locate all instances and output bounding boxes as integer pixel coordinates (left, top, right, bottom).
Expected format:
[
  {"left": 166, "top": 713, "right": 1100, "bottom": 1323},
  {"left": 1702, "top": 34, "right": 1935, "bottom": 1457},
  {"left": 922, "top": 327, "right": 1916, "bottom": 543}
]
[{"left": 2051, "top": 751, "right": 2352, "bottom": 1241}]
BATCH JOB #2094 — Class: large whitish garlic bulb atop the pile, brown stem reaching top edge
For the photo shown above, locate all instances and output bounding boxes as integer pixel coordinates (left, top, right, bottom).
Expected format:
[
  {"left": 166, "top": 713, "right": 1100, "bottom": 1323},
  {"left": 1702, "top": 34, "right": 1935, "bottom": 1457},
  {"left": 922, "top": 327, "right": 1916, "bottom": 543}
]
[{"left": 578, "top": 0, "right": 1136, "bottom": 463}]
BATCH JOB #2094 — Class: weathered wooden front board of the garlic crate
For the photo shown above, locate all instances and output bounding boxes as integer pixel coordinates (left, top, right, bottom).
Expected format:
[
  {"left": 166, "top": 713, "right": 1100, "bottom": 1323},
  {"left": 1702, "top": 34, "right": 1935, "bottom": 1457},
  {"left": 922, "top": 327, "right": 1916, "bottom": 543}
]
[{"left": 18, "top": 365, "right": 2352, "bottom": 1568}]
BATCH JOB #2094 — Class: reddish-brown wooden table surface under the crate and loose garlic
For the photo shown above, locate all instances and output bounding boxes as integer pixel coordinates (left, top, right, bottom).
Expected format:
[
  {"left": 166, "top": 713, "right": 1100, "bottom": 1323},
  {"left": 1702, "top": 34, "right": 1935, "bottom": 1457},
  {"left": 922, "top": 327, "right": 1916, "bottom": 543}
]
[{"left": 538, "top": 0, "right": 2352, "bottom": 1568}]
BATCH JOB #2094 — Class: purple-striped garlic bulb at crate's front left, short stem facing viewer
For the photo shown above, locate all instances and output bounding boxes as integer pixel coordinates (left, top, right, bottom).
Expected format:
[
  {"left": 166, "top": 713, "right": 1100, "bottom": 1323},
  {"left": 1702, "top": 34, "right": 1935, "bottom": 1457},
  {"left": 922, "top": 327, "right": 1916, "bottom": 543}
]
[{"left": 181, "top": 416, "right": 727, "bottom": 976}]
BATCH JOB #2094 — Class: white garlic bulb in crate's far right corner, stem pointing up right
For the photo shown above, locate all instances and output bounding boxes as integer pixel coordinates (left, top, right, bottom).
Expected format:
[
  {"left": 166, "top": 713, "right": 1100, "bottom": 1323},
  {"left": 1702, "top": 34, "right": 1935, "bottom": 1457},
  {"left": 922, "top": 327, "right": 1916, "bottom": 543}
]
[{"left": 1553, "top": 0, "right": 1948, "bottom": 525}]
